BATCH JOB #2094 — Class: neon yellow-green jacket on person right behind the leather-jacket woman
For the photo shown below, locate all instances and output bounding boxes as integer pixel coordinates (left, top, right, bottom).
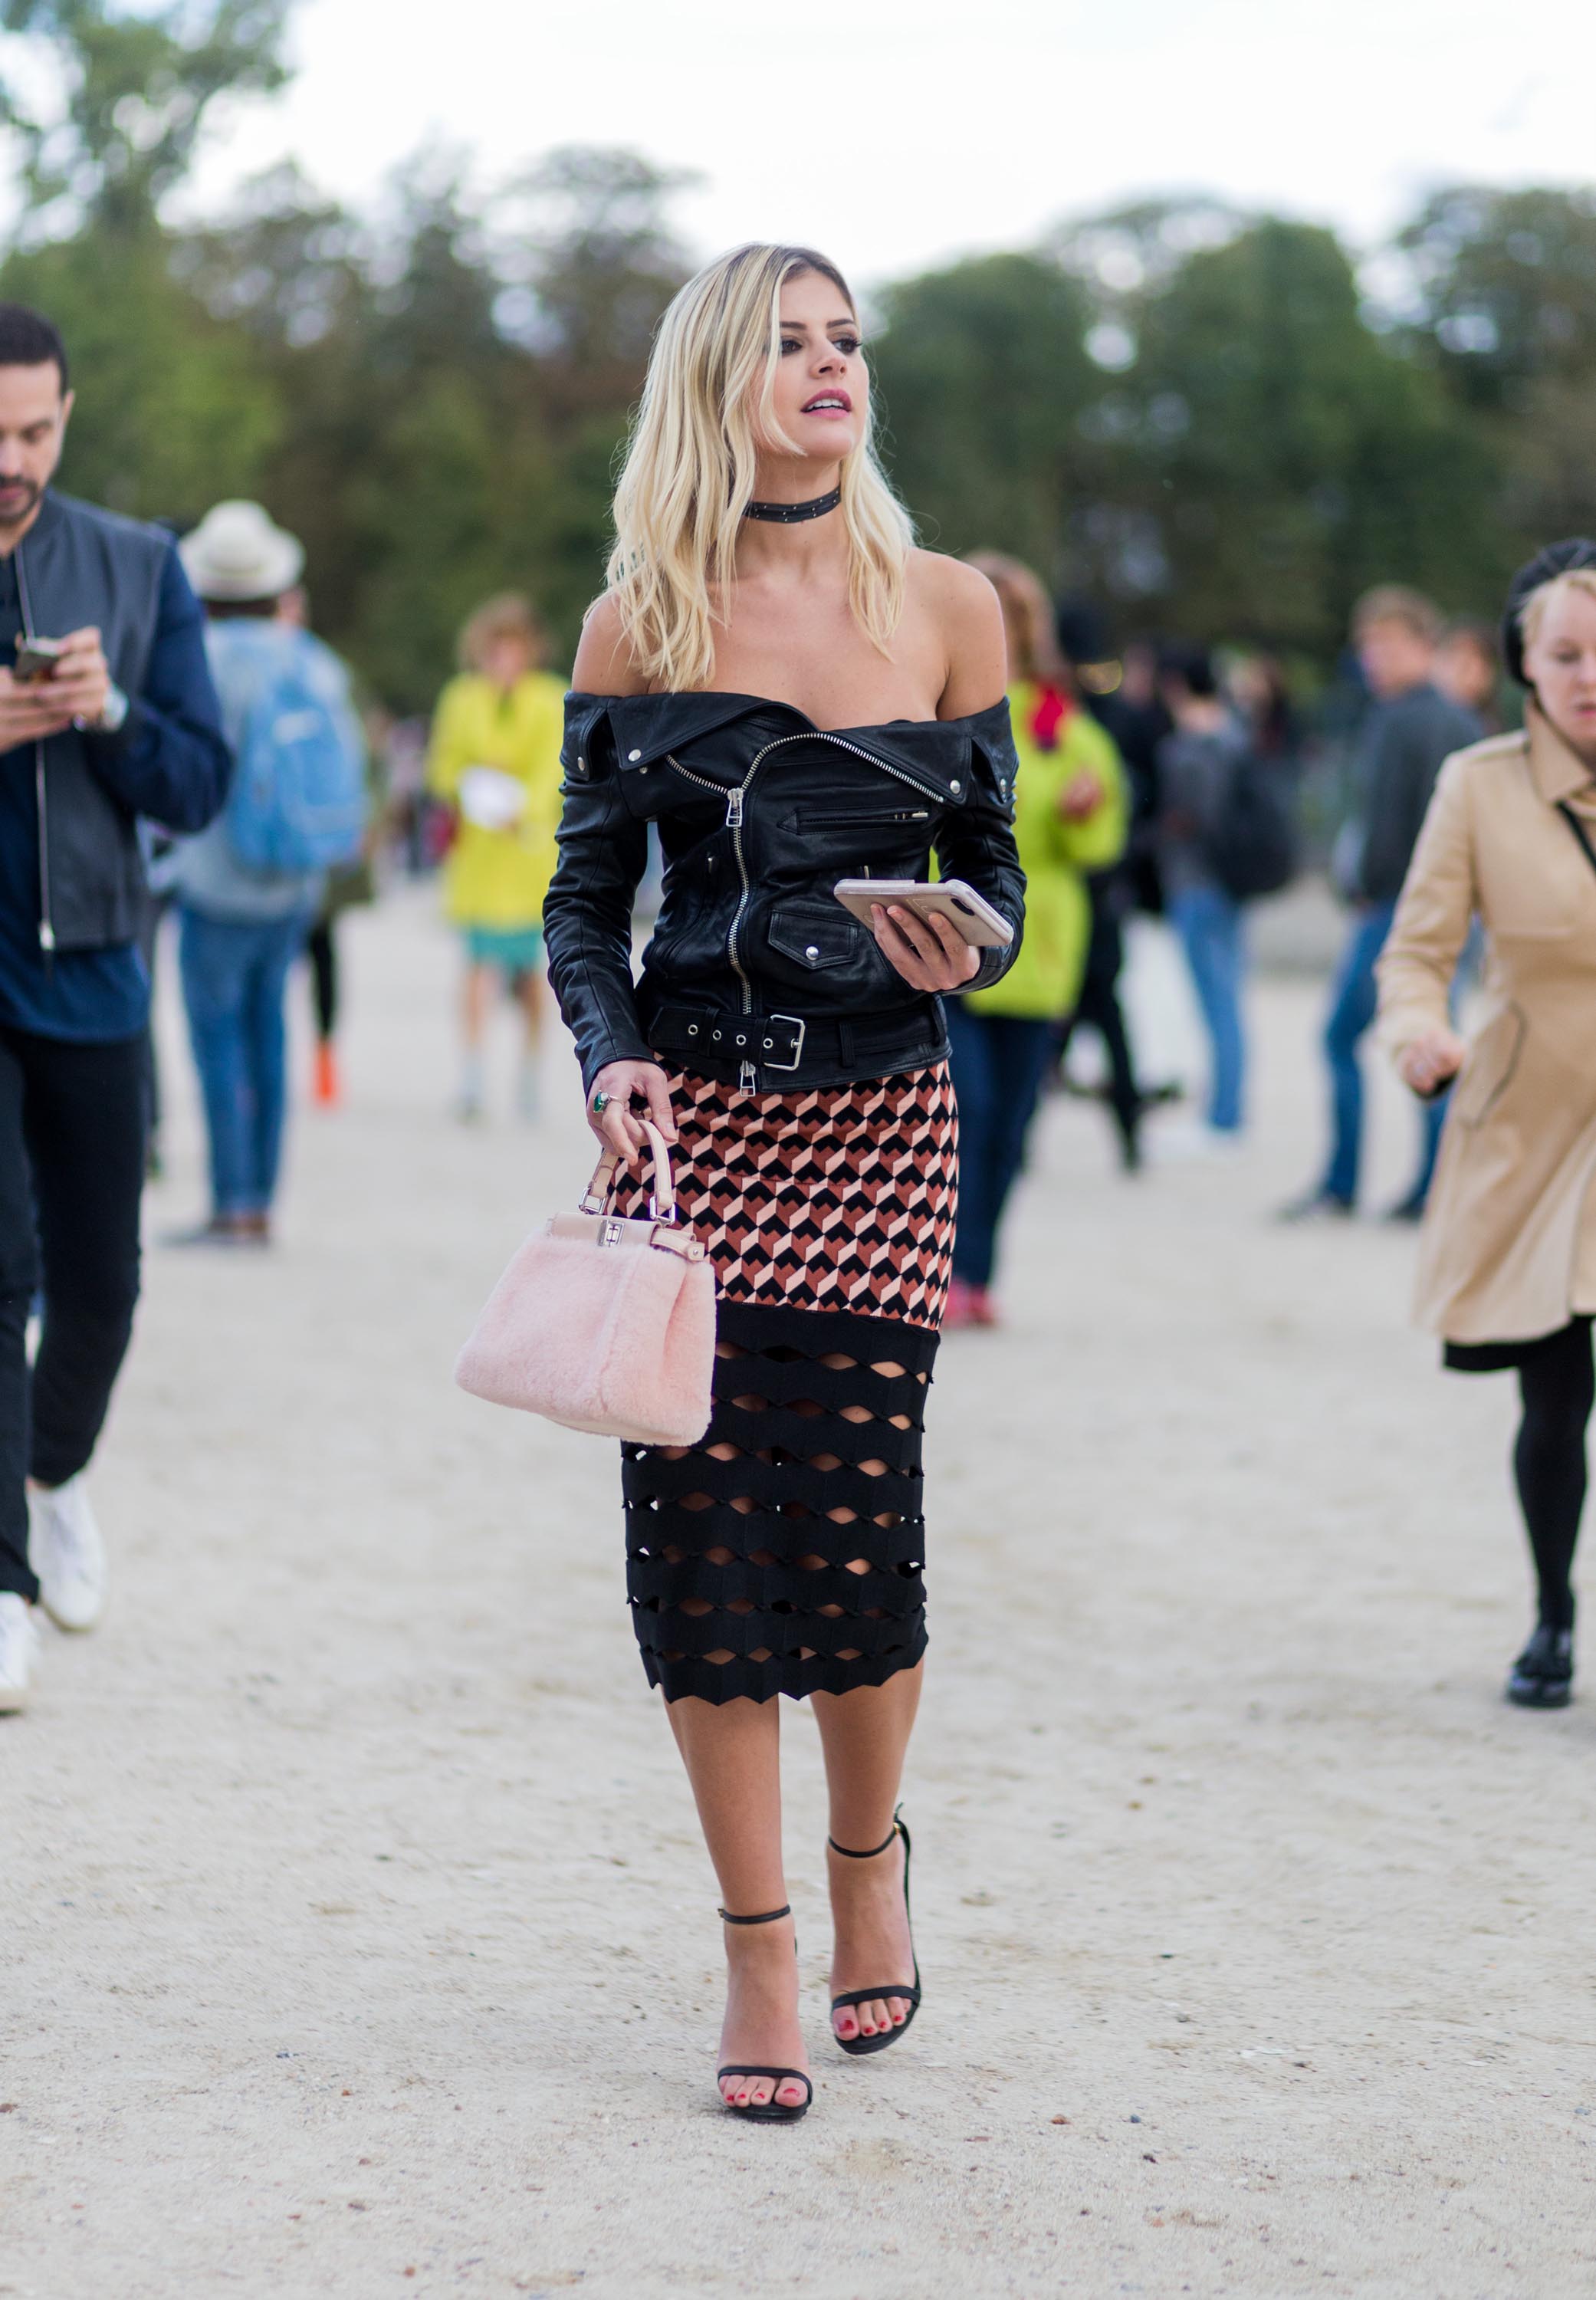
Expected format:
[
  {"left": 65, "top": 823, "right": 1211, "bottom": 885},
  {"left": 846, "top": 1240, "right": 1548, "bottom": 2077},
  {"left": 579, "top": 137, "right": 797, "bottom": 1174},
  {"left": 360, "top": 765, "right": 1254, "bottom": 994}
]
[{"left": 966, "top": 685, "right": 1129, "bottom": 1021}]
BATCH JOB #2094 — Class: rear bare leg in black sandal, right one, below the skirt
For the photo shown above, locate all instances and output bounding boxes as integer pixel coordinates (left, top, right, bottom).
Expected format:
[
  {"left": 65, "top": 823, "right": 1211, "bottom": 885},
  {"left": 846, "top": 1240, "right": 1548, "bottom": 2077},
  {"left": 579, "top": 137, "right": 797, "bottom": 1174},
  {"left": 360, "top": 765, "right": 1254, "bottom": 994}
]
[{"left": 814, "top": 1663, "right": 924, "bottom": 2036}]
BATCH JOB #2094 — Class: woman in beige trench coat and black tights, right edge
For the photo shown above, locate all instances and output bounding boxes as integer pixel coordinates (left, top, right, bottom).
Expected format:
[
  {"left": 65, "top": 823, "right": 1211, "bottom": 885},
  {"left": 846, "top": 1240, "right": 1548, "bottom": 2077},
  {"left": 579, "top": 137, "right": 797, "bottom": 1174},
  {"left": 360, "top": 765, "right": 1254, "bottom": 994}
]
[{"left": 1380, "top": 540, "right": 1596, "bottom": 1709}]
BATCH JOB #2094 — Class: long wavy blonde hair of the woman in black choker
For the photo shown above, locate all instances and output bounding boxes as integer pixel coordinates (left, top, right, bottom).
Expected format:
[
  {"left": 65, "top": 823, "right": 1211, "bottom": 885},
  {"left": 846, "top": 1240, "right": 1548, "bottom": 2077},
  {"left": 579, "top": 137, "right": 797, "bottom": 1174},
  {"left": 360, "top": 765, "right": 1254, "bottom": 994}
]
[{"left": 605, "top": 244, "right": 913, "bottom": 690}]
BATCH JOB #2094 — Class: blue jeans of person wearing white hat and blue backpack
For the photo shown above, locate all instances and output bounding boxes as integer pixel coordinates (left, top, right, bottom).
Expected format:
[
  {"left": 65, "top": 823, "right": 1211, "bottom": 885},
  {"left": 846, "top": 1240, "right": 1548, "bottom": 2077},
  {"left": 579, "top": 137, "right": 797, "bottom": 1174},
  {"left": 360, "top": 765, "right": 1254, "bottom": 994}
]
[{"left": 177, "top": 909, "right": 310, "bottom": 1214}]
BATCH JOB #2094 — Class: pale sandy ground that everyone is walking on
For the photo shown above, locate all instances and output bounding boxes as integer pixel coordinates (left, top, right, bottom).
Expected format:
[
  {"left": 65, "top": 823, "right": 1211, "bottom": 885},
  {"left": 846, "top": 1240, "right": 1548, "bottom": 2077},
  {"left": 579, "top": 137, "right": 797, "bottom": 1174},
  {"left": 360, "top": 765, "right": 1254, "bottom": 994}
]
[{"left": 0, "top": 897, "right": 1596, "bottom": 2300}]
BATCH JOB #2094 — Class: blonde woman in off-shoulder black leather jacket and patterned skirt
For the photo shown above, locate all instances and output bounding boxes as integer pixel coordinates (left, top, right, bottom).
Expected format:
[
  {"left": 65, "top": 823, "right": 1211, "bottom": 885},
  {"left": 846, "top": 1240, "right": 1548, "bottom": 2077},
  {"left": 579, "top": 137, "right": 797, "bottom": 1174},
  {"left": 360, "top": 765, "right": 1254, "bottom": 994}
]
[{"left": 545, "top": 246, "right": 1023, "bottom": 2121}]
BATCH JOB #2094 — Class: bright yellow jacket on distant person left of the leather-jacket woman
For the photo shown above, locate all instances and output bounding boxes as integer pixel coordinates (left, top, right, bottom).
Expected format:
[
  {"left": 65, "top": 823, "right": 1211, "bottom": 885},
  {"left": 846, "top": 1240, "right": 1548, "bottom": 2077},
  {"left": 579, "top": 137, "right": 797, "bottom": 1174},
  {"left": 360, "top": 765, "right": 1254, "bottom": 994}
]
[{"left": 428, "top": 672, "right": 566, "bottom": 929}]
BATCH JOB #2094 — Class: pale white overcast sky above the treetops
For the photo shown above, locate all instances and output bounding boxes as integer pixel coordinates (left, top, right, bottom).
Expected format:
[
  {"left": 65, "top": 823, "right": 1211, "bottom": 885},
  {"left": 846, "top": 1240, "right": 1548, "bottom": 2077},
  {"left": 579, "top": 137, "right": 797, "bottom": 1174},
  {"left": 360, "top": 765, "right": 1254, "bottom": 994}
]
[{"left": 182, "top": 0, "right": 1596, "bottom": 281}]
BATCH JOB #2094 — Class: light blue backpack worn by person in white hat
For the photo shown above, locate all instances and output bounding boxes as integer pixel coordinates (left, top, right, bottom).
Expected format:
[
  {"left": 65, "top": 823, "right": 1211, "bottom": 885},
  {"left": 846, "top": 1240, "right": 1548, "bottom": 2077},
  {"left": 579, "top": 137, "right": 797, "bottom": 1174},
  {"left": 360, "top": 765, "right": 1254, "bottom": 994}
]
[{"left": 205, "top": 616, "right": 366, "bottom": 876}]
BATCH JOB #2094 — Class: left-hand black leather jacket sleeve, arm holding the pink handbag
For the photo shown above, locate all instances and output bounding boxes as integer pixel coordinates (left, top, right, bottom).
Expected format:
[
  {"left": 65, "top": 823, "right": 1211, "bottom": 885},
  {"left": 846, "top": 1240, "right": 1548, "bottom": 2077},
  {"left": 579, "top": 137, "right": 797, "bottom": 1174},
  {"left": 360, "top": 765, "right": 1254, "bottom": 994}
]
[{"left": 543, "top": 702, "right": 653, "bottom": 1095}]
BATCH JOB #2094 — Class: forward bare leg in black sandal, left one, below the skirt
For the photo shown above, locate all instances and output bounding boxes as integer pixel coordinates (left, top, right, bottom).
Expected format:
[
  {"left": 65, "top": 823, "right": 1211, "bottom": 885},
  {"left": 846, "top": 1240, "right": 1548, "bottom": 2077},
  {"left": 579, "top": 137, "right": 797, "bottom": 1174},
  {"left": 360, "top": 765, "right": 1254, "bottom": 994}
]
[{"left": 665, "top": 1695, "right": 809, "bottom": 2107}]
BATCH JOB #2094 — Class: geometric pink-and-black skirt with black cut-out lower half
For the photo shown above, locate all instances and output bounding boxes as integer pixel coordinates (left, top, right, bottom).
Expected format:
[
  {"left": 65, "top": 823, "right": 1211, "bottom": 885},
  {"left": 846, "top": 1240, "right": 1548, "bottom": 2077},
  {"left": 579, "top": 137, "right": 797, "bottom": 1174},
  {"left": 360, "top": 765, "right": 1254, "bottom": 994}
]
[{"left": 616, "top": 1063, "right": 959, "bottom": 1702}]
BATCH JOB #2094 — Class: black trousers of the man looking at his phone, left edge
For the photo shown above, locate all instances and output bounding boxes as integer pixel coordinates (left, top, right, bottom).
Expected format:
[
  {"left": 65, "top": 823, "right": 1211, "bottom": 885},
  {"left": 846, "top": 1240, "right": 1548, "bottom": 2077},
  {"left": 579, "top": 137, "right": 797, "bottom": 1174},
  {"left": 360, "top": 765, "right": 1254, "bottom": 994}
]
[{"left": 0, "top": 1024, "right": 147, "bottom": 1598}]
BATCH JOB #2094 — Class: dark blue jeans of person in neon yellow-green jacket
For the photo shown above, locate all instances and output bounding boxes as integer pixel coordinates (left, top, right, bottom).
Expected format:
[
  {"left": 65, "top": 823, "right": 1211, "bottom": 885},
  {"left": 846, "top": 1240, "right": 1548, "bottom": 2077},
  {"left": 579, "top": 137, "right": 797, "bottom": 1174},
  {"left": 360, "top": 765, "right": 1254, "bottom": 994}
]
[{"left": 943, "top": 998, "right": 1058, "bottom": 1286}]
